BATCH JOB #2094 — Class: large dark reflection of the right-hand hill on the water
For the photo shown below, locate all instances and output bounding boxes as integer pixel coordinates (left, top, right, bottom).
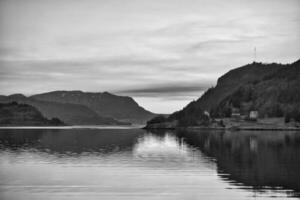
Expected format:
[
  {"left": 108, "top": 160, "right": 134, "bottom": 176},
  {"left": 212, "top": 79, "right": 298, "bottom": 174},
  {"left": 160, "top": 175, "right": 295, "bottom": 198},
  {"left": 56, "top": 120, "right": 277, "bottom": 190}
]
[{"left": 178, "top": 131, "right": 300, "bottom": 197}]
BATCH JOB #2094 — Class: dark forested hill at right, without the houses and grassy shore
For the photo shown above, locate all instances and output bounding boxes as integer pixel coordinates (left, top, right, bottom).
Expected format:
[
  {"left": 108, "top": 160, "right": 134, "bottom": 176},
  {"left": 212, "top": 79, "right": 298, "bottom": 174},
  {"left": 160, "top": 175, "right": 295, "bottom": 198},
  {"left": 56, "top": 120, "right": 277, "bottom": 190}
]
[{"left": 149, "top": 60, "right": 300, "bottom": 126}]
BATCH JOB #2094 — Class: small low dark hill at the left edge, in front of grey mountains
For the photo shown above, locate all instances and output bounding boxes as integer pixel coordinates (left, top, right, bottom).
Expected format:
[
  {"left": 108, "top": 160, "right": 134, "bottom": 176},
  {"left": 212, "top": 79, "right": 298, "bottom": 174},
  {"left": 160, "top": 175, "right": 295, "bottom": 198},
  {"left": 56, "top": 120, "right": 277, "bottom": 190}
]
[{"left": 0, "top": 102, "right": 64, "bottom": 126}]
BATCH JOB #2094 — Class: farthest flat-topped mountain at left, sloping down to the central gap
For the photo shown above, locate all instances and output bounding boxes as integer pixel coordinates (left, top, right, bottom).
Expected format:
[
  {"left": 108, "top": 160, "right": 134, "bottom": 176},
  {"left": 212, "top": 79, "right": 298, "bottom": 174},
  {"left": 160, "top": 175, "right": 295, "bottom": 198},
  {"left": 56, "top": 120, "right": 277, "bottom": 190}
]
[{"left": 30, "top": 91, "right": 155, "bottom": 124}]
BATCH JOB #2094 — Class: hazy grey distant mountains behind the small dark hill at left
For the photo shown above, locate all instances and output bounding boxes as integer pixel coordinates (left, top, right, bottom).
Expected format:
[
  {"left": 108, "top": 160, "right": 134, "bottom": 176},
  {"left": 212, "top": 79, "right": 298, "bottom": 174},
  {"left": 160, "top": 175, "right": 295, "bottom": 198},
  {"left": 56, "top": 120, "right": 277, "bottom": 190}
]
[{"left": 0, "top": 91, "right": 155, "bottom": 125}]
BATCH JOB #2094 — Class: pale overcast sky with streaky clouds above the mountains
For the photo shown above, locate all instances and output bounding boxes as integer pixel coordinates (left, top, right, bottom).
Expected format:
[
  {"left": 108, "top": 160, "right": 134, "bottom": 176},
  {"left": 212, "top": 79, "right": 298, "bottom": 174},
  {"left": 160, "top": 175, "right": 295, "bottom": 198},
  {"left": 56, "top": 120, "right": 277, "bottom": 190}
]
[{"left": 0, "top": 0, "right": 300, "bottom": 113}]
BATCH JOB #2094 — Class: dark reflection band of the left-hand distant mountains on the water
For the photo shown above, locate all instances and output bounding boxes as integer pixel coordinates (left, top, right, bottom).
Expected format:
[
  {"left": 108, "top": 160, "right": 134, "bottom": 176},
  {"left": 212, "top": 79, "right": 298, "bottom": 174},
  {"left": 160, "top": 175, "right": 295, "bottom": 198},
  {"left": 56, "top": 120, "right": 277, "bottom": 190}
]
[{"left": 0, "top": 129, "right": 143, "bottom": 154}]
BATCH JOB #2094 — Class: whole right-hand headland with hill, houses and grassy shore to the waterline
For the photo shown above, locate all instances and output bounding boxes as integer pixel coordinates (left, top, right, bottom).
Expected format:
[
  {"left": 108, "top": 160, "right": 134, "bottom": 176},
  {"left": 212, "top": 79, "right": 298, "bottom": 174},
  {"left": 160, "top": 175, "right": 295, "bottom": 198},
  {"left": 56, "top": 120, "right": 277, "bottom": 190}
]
[{"left": 145, "top": 60, "right": 300, "bottom": 130}]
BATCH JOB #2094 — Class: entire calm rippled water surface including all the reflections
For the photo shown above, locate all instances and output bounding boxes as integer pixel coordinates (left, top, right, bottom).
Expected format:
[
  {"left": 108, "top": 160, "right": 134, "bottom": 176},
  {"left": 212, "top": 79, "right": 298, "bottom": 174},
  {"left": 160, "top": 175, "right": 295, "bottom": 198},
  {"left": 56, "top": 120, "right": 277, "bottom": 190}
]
[{"left": 0, "top": 129, "right": 300, "bottom": 200}]
